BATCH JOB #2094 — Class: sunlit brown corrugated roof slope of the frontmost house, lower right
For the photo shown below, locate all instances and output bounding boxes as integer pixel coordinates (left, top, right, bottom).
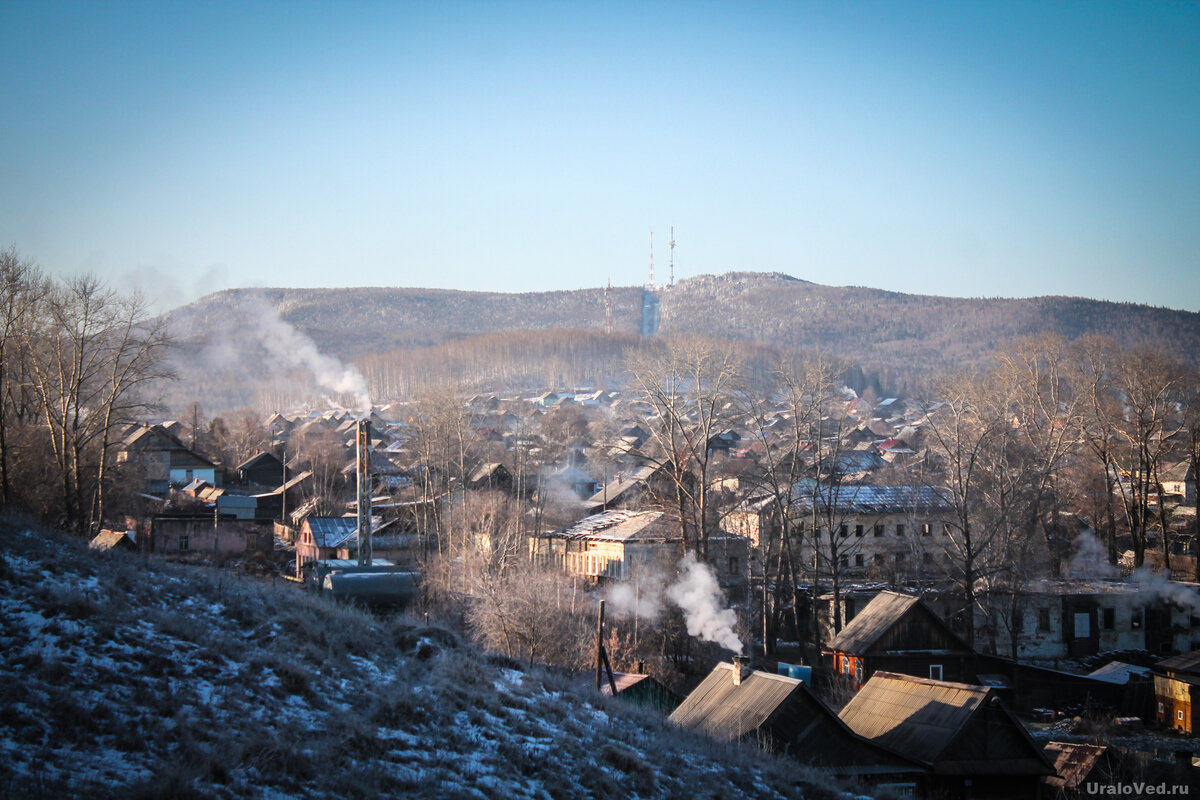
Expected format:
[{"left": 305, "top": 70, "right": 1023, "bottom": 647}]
[{"left": 838, "top": 672, "right": 990, "bottom": 764}]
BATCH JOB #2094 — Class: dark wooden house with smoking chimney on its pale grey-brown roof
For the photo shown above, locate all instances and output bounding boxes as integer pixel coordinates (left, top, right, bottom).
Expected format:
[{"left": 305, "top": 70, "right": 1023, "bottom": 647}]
[{"left": 671, "top": 658, "right": 924, "bottom": 788}]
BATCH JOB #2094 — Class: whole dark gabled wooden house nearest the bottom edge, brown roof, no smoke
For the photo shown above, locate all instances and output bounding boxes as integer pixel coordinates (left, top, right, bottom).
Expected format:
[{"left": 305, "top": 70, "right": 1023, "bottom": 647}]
[{"left": 839, "top": 672, "right": 1055, "bottom": 800}]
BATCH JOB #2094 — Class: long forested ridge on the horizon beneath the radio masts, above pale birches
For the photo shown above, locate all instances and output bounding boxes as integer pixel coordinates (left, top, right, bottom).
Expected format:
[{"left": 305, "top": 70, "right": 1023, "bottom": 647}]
[{"left": 172, "top": 272, "right": 1200, "bottom": 372}]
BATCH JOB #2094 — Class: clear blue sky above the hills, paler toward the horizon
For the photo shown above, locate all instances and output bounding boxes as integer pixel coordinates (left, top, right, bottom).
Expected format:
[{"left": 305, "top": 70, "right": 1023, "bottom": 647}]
[{"left": 0, "top": 0, "right": 1200, "bottom": 311}]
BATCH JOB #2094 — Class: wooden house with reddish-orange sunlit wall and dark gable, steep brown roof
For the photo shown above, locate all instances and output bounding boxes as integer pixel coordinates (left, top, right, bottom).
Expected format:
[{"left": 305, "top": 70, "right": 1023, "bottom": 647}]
[{"left": 824, "top": 591, "right": 976, "bottom": 690}]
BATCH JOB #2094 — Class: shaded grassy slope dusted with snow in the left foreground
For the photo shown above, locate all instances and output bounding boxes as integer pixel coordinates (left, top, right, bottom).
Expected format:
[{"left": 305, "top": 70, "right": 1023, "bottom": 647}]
[{"left": 0, "top": 519, "right": 835, "bottom": 799}]
